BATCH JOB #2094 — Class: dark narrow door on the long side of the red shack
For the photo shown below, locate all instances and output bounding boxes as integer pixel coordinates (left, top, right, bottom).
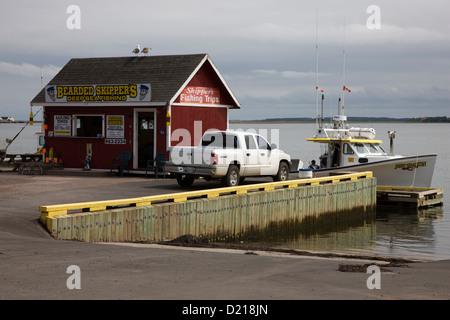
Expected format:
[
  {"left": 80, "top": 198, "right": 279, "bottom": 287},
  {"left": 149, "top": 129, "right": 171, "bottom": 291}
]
[{"left": 137, "top": 111, "right": 156, "bottom": 169}]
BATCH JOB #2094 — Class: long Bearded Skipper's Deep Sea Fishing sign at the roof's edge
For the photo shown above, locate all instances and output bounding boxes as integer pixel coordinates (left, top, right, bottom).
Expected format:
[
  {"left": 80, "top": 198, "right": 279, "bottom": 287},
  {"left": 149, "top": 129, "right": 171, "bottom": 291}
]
[{"left": 45, "top": 83, "right": 152, "bottom": 102}]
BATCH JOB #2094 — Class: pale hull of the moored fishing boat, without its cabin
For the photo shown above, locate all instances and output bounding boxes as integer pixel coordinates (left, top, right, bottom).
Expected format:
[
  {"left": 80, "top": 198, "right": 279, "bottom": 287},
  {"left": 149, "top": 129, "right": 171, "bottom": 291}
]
[{"left": 314, "top": 154, "right": 437, "bottom": 188}]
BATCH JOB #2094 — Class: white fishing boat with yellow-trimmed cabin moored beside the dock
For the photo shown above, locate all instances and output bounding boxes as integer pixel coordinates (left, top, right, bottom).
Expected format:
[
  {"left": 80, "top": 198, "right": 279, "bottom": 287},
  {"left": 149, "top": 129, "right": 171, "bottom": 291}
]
[{"left": 307, "top": 115, "right": 437, "bottom": 188}]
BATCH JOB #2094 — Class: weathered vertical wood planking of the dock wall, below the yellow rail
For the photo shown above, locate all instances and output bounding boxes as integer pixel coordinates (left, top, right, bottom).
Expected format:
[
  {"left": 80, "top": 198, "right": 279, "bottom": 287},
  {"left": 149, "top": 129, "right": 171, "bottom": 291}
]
[{"left": 50, "top": 178, "right": 376, "bottom": 242}]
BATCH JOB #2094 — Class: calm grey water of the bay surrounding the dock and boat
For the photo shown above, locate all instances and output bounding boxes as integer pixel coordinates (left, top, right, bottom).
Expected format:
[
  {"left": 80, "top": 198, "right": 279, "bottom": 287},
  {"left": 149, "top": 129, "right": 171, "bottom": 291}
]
[{"left": 0, "top": 123, "right": 450, "bottom": 260}]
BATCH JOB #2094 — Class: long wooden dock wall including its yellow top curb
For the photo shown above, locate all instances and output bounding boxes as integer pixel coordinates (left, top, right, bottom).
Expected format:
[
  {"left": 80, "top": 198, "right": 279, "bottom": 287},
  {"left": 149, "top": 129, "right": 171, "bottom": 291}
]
[{"left": 40, "top": 172, "right": 376, "bottom": 242}]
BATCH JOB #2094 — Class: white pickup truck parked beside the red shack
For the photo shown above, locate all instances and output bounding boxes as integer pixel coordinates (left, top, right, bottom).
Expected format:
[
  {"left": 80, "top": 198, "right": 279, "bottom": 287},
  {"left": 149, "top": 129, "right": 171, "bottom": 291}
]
[{"left": 166, "top": 131, "right": 291, "bottom": 187}]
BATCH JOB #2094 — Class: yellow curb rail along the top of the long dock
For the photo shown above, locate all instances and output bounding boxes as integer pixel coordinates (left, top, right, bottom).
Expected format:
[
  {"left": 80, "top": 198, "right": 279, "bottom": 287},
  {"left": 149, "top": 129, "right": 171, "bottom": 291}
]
[{"left": 39, "top": 171, "right": 373, "bottom": 228}]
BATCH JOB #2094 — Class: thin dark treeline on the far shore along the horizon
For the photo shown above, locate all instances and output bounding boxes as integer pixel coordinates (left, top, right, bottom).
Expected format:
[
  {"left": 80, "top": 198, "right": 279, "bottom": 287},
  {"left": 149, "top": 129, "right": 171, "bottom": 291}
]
[{"left": 230, "top": 116, "right": 450, "bottom": 123}]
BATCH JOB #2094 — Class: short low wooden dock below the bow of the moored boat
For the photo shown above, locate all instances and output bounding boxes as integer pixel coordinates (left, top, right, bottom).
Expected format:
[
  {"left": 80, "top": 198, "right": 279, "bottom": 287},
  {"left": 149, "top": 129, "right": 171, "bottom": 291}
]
[{"left": 377, "top": 186, "right": 444, "bottom": 209}]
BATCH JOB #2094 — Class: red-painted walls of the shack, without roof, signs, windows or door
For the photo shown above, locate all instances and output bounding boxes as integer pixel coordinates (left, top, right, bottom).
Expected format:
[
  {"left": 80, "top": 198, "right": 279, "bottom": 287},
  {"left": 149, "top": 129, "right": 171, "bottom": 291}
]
[{"left": 44, "top": 59, "right": 235, "bottom": 169}]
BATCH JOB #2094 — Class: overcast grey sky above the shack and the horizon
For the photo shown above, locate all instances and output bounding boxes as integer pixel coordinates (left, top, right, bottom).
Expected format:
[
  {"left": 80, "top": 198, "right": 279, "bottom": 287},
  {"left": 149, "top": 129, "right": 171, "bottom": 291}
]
[{"left": 0, "top": 0, "right": 450, "bottom": 120}]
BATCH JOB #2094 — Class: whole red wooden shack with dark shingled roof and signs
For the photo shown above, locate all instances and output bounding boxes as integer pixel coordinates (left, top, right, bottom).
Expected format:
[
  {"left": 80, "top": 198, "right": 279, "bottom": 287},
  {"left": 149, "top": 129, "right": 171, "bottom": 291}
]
[{"left": 31, "top": 54, "right": 240, "bottom": 171}]
